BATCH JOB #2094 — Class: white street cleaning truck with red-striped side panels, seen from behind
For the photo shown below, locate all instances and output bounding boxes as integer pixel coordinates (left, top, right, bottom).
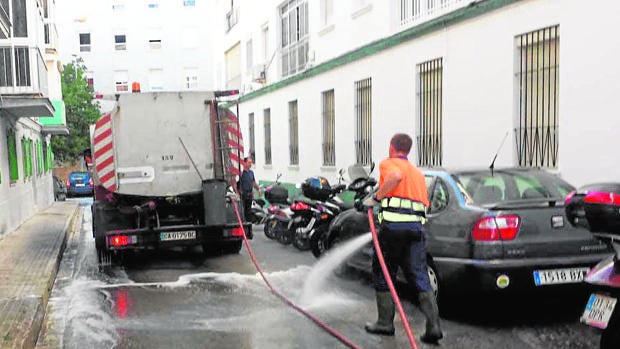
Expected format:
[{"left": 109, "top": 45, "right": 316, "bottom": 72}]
[{"left": 91, "top": 91, "right": 251, "bottom": 263}]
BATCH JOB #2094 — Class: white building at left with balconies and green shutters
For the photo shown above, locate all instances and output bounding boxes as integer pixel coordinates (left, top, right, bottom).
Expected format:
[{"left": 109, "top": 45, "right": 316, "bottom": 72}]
[{"left": 0, "top": 0, "right": 68, "bottom": 237}]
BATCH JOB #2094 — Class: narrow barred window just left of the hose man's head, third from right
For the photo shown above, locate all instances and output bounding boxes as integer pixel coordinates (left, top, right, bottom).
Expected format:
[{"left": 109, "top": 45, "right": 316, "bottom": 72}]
[{"left": 355, "top": 78, "right": 372, "bottom": 165}]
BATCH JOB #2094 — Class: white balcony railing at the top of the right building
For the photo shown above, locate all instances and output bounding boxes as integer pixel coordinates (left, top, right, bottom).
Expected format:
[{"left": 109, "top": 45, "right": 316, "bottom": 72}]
[{"left": 399, "top": 0, "right": 478, "bottom": 29}]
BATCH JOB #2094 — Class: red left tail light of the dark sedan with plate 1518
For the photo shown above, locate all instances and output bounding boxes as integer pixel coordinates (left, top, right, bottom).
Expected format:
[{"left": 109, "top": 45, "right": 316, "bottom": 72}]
[{"left": 471, "top": 215, "right": 521, "bottom": 241}]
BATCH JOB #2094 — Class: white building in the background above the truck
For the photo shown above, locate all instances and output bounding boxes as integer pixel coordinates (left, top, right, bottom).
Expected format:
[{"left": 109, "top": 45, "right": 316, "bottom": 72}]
[{"left": 57, "top": 0, "right": 223, "bottom": 95}]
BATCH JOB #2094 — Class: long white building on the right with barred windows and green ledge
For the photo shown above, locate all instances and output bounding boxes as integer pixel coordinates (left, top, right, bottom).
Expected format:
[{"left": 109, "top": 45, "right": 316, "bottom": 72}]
[{"left": 215, "top": 0, "right": 620, "bottom": 189}]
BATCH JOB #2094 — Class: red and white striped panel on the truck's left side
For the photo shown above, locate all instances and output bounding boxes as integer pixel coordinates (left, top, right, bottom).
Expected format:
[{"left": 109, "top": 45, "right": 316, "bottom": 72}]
[{"left": 93, "top": 114, "right": 117, "bottom": 191}]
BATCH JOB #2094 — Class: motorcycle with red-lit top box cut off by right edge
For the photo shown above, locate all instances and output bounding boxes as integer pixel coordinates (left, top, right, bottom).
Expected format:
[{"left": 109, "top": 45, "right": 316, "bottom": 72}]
[{"left": 565, "top": 183, "right": 620, "bottom": 349}]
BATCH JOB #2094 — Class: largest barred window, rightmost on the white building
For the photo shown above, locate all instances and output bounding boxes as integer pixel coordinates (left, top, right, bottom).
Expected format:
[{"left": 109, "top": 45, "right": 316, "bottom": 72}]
[{"left": 515, "top": 25, "right": 560, "bottom": 168}]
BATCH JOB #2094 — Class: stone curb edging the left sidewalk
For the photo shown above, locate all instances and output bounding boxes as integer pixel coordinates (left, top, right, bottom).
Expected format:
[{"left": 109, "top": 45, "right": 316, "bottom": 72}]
[{"left": 27, "top": 204, "right": 81, "bottom": 348}]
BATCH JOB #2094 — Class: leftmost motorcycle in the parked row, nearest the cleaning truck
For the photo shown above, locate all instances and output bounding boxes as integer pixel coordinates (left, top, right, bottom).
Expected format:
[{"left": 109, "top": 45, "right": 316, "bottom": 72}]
[{"left": 263, "top": 173, "right": 293, "bottom": 239}]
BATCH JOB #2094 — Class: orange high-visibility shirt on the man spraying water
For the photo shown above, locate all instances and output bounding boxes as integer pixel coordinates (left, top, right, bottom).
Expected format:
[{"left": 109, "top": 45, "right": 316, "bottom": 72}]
[{"left": 379, "top": 158, "right": 429, "bottom": 207}]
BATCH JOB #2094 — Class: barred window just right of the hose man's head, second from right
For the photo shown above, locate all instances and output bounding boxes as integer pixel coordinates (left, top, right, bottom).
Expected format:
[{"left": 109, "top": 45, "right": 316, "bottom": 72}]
[{"left": 416, "top": 58, "right": 443, "bottom": 167}]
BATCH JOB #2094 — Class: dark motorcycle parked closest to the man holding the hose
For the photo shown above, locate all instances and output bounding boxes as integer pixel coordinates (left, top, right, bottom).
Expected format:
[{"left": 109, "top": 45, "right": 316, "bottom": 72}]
[{"left": 310, "top": 163, "right": 377, "bottom": 258}]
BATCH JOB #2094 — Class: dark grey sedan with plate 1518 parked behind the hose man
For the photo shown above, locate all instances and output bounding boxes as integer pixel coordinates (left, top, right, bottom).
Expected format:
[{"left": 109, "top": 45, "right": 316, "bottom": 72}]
[{"left": 336, "top": 169, "right": 611, "bottom": 302}]
